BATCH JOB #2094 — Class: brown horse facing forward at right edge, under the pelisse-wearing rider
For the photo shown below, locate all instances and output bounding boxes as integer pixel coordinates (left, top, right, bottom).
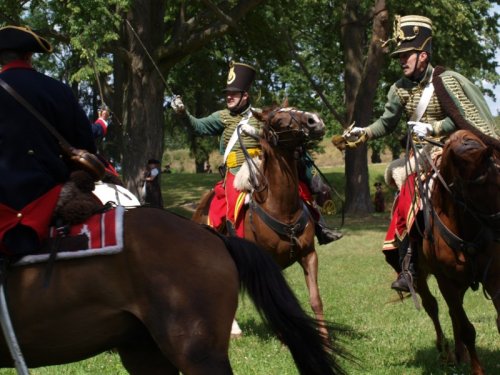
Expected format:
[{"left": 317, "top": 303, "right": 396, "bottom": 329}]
[{"left": 417, "top": 130, "right": 500, "bottom": 375}]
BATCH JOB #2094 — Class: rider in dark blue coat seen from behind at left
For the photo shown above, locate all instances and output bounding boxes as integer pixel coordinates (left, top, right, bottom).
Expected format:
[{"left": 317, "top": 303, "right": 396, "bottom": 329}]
[{"left": 0, "top": 26, "right": 96, "bottom": 256}]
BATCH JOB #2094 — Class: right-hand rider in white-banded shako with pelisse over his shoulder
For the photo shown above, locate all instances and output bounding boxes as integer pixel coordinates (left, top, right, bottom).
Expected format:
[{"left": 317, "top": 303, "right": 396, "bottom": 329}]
[{"left": 338, "top": 15, "right": 500, "bottom": 292}]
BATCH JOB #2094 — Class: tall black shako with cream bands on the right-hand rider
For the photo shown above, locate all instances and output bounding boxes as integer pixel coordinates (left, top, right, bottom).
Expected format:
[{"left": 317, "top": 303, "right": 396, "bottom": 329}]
[{"left": 391, "top": 16, "right": 432, "bottom": 57}]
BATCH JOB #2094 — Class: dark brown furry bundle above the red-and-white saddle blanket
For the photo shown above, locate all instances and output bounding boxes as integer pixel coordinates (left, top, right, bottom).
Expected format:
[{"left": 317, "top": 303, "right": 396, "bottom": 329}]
[{"left": 53, "top": 170, "right": 101, "bottom": 224}]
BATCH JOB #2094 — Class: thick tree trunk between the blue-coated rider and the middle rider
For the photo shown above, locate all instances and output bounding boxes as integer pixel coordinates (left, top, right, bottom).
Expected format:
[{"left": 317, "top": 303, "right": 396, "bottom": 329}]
[{"left": 123, "top": 0, "right": 165, "bottom": 194}]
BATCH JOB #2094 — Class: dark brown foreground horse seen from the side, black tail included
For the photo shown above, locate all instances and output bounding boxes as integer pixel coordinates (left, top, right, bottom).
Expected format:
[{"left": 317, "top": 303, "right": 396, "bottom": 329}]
[{"left": 0, "top": 208, "right": 343, "bottom": 375}]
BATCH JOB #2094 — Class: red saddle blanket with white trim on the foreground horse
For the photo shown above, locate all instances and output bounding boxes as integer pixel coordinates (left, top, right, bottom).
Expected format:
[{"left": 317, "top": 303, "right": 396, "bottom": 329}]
[{"left": 15, "top": 206, "right": 125, "bottom": 266}]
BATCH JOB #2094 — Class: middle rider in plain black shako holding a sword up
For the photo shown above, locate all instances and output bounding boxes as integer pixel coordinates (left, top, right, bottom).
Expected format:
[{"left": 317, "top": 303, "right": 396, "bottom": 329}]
[{"left": 171, "top": 62, "right": 342, "bottom": 244}]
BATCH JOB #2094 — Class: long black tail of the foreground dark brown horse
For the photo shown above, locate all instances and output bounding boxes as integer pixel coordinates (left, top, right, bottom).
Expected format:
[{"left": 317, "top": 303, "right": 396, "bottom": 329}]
[{"left": 224, "top": 237, "right": 350, "bottom": 375}]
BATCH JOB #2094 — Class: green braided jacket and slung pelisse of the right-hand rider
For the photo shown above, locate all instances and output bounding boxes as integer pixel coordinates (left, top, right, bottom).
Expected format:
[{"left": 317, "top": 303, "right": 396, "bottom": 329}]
[{"left": 367, "top": 64, "right": 500, "bottom": 142}]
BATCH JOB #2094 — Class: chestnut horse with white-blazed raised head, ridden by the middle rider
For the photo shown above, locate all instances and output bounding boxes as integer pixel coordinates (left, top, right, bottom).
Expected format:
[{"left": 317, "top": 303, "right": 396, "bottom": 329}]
[{"left": 192, "top": 107, "right": 325, "bottom": 328}]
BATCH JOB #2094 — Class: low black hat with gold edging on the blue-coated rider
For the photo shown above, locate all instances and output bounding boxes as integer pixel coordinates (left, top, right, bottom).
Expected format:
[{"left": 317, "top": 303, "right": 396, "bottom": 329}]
[{"left": 0, "top": 26, "right": 53, "bottom": 53}]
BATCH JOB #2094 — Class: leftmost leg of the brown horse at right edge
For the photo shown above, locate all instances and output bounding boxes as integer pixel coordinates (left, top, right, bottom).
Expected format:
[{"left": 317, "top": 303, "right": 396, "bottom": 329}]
[{"left": 417, "top": 269, "right": 454, "bottom": 363}]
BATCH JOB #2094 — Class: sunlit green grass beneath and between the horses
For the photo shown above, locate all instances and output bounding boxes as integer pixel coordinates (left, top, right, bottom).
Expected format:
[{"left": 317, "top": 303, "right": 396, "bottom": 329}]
[{"left": 0, "top": 165, "right": 500, "bottom": 375}]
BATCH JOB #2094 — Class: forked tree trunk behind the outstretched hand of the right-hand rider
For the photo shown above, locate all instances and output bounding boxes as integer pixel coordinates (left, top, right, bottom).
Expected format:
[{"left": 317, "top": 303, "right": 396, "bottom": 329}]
[{"left": 342, "top": 0, "right": 388, "bottom": 214}]
